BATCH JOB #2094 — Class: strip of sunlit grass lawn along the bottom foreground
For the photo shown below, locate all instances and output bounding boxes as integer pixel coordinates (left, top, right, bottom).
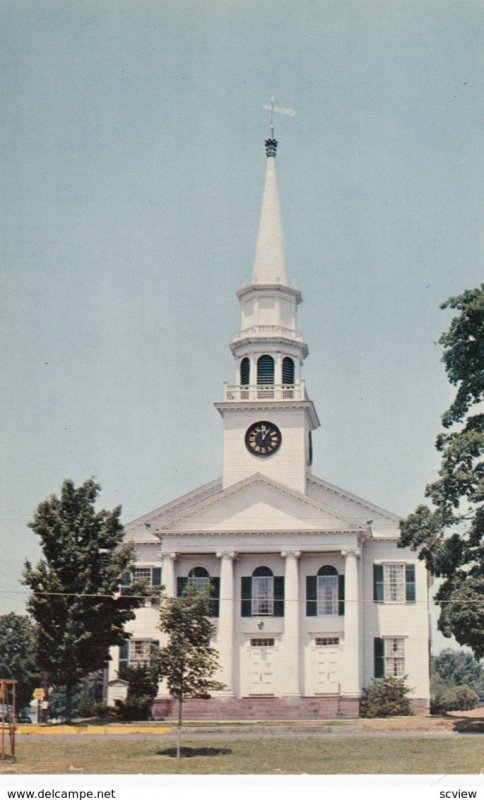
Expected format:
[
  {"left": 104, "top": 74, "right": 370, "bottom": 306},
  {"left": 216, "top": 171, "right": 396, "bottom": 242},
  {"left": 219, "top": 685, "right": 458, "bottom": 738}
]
[{"left": 0, "top": 735, "right": 484, "bottom": 775}]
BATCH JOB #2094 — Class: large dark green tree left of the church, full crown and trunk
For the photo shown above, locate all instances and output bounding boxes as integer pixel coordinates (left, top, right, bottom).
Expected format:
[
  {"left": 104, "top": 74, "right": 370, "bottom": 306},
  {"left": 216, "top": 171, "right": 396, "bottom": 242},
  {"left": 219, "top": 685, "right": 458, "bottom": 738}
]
[{"left": 24, "top": 480, "right": 145, "bottom": 722}]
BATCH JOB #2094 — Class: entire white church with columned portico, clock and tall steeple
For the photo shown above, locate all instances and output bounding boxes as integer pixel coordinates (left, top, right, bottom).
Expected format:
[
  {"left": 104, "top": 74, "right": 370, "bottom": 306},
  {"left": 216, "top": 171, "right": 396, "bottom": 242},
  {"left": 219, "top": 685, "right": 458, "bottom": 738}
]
[{"left": 108, "top": 128, "right": 429, "bottom": 719}]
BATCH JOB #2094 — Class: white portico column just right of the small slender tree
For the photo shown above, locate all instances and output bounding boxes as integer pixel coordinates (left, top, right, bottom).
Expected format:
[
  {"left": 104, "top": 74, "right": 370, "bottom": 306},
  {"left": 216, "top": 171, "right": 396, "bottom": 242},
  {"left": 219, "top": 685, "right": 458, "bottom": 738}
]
[{"left": 217, "top": 553, "right": 236, "bottom": 694}]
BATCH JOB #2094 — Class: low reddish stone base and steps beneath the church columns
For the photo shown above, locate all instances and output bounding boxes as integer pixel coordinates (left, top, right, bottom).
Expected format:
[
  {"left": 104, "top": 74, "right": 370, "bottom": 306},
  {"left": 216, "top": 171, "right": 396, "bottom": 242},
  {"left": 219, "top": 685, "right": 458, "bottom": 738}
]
[{"left": 152, "top": 695, "right": 360, "bottom": 721}]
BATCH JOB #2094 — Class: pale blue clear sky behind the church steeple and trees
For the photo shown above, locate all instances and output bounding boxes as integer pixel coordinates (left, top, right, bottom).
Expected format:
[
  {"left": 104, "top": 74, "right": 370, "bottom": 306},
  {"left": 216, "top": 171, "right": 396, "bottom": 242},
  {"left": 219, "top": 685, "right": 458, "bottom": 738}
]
[{"left": 0, "top": 0, "right": 484, "bottom": 648}]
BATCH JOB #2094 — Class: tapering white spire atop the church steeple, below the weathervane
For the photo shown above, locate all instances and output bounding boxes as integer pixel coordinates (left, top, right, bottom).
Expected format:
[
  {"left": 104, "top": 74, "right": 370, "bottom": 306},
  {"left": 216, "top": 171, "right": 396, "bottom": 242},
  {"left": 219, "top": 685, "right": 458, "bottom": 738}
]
[{"left": 252, "top": 130, "right": 287, "bottom": 286}]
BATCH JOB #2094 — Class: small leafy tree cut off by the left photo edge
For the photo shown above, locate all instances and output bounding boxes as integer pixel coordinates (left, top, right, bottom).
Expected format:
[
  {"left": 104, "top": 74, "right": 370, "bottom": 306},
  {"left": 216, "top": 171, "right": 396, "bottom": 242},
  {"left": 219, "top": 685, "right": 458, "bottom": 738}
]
[{"left": 0, "top": 612, "right": 40, "bottom": 712}]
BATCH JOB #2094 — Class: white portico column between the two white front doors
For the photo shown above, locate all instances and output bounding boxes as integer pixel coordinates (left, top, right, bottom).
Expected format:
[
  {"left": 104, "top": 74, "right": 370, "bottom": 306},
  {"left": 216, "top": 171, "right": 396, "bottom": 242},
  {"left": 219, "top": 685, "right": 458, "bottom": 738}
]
[{"left": 281, "top": 551, "right": 301, "bottom": 695}]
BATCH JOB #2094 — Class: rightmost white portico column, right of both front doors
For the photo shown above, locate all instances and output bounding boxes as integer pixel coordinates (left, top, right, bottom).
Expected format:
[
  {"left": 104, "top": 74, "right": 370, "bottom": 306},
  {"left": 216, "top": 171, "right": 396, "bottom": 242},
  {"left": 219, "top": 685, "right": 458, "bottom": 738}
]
[{"left": 341, "top": 550, "right": 361, "bottom": 695}]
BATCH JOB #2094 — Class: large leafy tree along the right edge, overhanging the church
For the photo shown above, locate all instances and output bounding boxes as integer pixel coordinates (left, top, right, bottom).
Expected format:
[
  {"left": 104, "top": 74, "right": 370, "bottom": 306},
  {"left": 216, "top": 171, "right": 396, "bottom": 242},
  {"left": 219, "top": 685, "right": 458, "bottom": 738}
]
[{"left": 400, "top": 284, "right": 484, "bottom": 659}]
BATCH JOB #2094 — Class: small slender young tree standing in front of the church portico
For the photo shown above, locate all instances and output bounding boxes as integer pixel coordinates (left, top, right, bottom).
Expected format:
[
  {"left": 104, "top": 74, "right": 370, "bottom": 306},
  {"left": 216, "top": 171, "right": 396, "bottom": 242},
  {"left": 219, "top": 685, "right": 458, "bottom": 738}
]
[{"left": 159, "top": 584, "right": 224, "bottom": 758}]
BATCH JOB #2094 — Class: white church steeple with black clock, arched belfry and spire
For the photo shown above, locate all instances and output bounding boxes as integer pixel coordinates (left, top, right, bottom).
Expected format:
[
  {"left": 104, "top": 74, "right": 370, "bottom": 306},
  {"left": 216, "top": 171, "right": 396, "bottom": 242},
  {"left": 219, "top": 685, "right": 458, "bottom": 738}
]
[{"left": 215, "top": 125, "right": 319, "bottom": 493}]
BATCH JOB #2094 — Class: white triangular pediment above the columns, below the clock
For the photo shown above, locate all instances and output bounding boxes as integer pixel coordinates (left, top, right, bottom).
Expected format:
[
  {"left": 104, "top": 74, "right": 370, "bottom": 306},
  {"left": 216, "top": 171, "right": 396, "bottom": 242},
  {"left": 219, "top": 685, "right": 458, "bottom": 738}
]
[{"left": 149, "top": 473, "right": 357, "bottom": 533}]
